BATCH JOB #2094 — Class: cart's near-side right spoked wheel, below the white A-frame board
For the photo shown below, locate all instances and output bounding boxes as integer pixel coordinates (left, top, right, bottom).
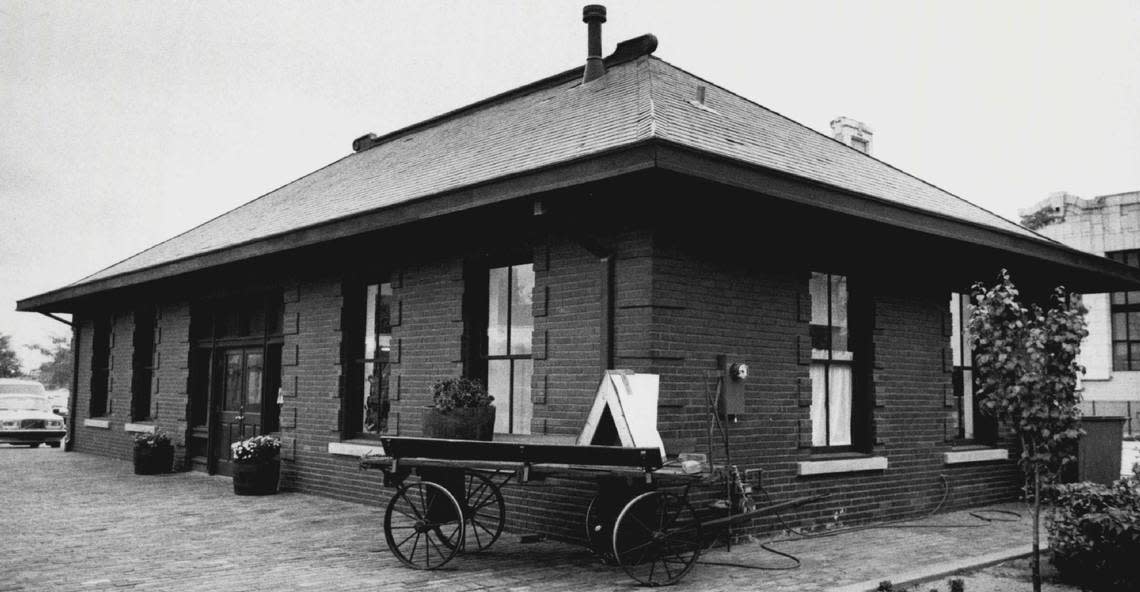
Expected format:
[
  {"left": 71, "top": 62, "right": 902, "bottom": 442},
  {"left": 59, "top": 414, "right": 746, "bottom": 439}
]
[{"left": 613, "top": 492, "right": 701, "bottom": 586}]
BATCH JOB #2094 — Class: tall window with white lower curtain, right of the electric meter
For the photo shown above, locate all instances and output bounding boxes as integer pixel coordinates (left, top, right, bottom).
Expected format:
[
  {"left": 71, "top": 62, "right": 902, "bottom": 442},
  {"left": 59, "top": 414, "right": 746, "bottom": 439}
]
[{"left": 809, "top": 273, "right": 855, "bottom": 448}]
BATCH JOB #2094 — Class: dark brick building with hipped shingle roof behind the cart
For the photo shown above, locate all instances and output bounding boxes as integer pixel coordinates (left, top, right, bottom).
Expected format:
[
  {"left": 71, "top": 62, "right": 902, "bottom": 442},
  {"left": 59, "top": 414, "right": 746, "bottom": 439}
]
[{"left": 18, "top": 12, "right": 1140, "bottom": 537}]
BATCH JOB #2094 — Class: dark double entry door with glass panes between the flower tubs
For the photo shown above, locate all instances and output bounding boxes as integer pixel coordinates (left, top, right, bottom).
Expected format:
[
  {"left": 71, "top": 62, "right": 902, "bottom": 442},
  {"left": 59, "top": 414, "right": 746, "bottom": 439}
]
[{"left": 210, "top": 346, "right": 280, "bottom": 475}]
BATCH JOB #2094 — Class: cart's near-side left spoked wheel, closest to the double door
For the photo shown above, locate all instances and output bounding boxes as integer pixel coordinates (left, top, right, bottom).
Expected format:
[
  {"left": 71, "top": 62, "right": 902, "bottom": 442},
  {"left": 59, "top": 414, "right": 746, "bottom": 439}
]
[{"left": 384, "top": 481, "right": 464, "bottom": 569}]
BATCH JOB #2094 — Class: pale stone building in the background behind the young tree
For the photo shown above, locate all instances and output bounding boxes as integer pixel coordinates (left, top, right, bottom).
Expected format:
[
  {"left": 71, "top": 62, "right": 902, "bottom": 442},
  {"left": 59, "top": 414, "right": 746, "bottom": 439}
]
[{"left": 1019, "top": 192, "right": 1140, "bottom": 433}]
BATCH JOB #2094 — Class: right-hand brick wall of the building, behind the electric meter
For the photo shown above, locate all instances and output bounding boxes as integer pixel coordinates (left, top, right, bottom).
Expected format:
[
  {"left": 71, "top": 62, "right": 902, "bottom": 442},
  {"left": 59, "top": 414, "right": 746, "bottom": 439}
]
[{"left": 652, "top": 241, "right": 1019, "bottom": 527}]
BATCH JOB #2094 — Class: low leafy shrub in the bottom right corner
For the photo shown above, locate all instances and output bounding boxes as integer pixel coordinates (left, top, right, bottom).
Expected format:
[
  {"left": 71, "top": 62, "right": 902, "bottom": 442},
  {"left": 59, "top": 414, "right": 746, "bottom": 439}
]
[{"left": 1047, "top": 463, "right": 1140, "bottom": 591}]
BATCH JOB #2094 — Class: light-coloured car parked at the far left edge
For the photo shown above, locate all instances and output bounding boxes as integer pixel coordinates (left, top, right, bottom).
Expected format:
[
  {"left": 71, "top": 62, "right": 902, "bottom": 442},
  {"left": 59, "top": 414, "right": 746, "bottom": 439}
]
[{"left": 0, "top": 379, "right": 67, "bottom": 448}]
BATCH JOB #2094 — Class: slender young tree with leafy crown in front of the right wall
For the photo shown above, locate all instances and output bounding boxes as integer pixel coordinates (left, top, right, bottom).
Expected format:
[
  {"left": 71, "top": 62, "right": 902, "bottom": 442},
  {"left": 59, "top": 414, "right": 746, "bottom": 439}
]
[{"left": 970, "top": 269, "right": 1089, "bottom": 592}]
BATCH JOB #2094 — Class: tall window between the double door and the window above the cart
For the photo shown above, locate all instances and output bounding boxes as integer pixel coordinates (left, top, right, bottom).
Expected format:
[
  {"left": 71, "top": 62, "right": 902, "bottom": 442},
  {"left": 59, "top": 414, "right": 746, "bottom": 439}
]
[{"left": 343, "top": 282, "right": 392, "bottom": 438}]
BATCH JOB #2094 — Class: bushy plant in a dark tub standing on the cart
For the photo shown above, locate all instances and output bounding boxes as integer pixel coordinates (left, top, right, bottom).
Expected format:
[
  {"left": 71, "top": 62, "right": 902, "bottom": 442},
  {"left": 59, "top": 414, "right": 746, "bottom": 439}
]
[{"left": 423, "top": 378, "right": 495, "bottom": 440}]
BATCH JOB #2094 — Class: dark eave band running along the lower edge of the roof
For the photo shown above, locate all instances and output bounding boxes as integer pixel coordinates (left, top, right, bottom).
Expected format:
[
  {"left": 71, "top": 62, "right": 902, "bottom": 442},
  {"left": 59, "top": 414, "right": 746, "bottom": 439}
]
[{"left": 16, "top": 138, "right": 1140, "bottom": 313}]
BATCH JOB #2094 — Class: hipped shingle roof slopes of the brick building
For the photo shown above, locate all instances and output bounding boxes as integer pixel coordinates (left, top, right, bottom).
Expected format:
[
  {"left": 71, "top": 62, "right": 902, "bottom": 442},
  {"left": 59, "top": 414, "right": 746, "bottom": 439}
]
[{"left": 72, "top": 56, "right": 1041, "bottom": 286}]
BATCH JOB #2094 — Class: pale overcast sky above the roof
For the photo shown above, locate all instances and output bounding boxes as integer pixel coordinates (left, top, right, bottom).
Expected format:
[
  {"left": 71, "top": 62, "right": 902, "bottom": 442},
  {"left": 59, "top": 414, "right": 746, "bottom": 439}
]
[{"left": 0, "top": 0, "right": 1140, "bottom": 366}]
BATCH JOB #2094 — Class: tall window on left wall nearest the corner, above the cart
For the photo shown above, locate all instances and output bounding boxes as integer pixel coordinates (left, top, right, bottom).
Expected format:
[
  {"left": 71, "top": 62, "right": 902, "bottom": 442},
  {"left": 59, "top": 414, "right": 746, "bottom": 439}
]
[{"left": 487, "top": 263, "right": 535, "bottom": 433}]
